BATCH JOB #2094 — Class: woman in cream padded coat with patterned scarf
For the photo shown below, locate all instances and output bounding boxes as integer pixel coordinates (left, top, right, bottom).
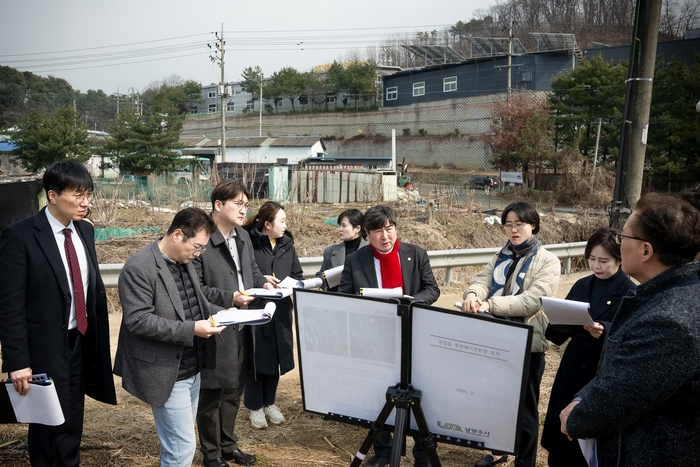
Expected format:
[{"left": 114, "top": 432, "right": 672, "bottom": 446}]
[{"left": 462, "top": 202, "right": 561, "bottom": 467}]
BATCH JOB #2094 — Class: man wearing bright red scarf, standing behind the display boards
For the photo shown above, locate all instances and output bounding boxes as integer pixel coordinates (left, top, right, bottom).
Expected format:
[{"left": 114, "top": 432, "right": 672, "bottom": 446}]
[{"left": 338, "top": 205, "right": 440, "bottom": 467}]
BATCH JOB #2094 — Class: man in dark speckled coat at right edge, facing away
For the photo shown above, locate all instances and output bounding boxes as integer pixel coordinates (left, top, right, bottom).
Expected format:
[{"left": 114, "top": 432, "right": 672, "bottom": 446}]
[{"left": 560, "top": 193, "right": 700, "bottom": 467}]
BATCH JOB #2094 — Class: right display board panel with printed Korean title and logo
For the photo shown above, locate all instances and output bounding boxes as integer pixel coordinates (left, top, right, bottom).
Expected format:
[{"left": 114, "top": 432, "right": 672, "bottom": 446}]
[{"left": 411, "top": 305, "right": 532, "bottom": 453}]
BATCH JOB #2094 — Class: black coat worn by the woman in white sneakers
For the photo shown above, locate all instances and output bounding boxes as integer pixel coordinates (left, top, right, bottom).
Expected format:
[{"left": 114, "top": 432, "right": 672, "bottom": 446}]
[{"left": 244, "top": 228, "right": 304, "bottom": 377}]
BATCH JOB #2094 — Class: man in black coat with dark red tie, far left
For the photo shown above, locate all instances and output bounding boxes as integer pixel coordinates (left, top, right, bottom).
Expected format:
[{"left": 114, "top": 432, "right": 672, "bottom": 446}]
[{"left": 0, "top": 161, "right": 117, "bottom": 466}]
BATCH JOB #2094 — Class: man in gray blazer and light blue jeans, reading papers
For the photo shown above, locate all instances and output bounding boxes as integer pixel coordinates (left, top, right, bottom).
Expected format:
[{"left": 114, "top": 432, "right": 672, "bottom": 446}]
[{"left": 114, "top": 208, "right": 223, "bottom": 467}]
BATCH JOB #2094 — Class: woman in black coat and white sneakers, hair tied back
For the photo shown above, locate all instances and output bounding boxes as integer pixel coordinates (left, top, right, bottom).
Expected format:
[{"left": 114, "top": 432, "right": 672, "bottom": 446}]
[{"left": 244, "top": 201, "right": 304, "bottom": 428}]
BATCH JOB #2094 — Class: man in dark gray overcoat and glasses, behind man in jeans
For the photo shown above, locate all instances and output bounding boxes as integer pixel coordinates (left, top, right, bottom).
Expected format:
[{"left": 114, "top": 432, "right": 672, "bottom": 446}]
[{"left": 193, "top": 180, "right": 273, "bottom": 467}]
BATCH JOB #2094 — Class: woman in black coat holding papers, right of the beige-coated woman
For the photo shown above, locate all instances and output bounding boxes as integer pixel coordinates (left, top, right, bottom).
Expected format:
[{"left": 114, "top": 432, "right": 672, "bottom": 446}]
[{"left": 541, "top": 228, "right": 636, "bottom": 467}]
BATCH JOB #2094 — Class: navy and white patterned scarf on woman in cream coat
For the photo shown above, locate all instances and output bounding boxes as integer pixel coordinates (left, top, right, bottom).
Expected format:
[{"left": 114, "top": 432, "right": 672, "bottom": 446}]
[{"left": 488, "top": 235, "right": 542, "bottom": 298}]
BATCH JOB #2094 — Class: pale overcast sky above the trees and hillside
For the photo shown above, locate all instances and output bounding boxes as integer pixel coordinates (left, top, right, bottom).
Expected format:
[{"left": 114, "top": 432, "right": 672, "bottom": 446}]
[{"left": 0, "top": 0, "right": 489, "bottom": 94}]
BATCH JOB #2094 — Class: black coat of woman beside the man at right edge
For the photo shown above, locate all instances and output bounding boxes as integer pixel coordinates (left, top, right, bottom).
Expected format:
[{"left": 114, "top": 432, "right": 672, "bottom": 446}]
[{"left": 541, "top": 271, "right": 636, "bottom": 467}]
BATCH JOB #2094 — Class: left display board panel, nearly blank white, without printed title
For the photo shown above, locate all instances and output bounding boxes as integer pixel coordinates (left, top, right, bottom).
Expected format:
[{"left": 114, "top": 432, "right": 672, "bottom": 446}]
[{"left": 294, "top": 289, "right": 401, "bottom": 425}]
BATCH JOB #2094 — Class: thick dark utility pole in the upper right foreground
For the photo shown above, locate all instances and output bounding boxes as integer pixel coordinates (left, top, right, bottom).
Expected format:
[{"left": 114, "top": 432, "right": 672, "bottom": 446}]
[{"left": 610, "top": 0, "right": 661, "bottom": 229}]
